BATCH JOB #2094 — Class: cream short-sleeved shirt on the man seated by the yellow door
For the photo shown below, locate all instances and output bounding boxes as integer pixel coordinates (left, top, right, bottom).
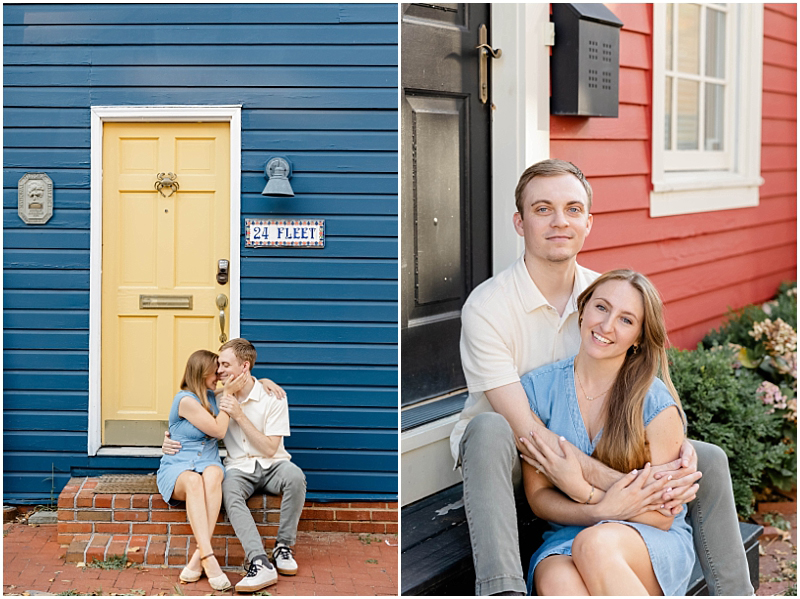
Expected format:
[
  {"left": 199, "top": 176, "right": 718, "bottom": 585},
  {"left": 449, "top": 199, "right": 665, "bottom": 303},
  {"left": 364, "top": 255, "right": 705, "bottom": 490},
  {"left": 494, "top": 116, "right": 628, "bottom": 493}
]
[{"left": 225, "top": 382, "right": 292, "bottom": 474}]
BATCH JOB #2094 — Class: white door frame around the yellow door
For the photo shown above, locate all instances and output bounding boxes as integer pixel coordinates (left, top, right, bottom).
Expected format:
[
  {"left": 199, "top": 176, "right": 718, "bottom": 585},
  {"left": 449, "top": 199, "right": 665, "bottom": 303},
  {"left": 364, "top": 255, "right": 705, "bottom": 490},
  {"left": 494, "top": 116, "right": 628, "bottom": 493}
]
[{"left": 87, "top": 104, "right": 242, "bottom": 456}]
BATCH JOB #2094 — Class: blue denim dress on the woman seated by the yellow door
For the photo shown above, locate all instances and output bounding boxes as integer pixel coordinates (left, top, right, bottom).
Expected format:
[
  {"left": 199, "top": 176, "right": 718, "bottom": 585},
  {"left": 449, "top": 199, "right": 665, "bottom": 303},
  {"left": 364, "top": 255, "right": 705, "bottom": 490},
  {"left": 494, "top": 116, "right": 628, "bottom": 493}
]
[{"left": 156, "top": 391, "right": 225, "bottom": 507}]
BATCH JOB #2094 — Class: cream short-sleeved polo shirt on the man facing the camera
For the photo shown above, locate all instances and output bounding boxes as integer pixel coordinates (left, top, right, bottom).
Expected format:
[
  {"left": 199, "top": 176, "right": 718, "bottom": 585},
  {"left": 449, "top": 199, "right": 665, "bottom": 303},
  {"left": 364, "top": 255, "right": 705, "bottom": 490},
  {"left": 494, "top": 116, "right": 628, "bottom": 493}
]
[{"left": 450, "top": 254, "right": 599, "bottom": 463}]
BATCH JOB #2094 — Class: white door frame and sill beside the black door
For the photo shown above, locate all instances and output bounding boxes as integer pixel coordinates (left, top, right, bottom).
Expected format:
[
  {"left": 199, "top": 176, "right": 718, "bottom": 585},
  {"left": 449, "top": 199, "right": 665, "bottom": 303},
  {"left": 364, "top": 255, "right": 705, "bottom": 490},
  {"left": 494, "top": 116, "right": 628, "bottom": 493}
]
[{"left": 400, "top": 9, "right": 552, "bottom": 505}]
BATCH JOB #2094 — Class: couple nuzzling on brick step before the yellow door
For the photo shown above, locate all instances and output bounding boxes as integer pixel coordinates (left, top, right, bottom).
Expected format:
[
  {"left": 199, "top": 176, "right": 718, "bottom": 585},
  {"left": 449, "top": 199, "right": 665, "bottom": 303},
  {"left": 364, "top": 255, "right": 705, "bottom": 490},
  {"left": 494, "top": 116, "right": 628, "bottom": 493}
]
[{"left": 157, "top": 339, "right": 306, "bottom": 592}]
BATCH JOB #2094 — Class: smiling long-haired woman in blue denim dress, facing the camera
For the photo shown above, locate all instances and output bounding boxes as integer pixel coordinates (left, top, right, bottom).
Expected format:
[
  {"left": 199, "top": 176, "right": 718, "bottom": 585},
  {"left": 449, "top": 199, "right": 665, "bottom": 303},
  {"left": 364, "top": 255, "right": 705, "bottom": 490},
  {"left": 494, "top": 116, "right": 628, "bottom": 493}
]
[{"left": 521, "top": 270, "right": 695, "bottom": 595}]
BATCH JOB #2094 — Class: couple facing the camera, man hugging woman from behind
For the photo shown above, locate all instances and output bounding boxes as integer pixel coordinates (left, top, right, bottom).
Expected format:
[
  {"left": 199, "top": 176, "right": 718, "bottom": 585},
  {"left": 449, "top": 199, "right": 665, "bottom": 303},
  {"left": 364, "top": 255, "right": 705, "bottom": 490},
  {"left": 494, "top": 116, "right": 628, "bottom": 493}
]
[{"left": 451, "top": 160, "right": 753, "bottom": 595}]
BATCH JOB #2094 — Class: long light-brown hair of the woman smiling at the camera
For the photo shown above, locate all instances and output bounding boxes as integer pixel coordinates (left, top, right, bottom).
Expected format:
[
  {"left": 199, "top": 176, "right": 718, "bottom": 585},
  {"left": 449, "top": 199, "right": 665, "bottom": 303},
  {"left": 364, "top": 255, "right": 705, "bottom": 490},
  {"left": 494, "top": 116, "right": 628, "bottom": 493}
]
[{"left": 578, "top": 269, "right": 683, "bottom": 472}]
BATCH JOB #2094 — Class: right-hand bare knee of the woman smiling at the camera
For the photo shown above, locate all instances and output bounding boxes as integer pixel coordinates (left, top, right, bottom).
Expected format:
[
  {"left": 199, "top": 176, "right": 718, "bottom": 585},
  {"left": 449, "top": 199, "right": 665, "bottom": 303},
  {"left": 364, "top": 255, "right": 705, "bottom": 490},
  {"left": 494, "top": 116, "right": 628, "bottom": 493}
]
[{"left": 572, "top": 522, "right": 663, "bottom": 596}]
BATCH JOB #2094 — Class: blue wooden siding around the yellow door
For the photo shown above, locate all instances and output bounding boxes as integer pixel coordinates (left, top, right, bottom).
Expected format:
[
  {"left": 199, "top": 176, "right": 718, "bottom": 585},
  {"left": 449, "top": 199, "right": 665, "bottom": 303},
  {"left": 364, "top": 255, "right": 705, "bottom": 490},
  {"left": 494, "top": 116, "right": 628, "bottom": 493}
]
[{"left": 3, "top": 4, "right": 398, "bottom": 502}]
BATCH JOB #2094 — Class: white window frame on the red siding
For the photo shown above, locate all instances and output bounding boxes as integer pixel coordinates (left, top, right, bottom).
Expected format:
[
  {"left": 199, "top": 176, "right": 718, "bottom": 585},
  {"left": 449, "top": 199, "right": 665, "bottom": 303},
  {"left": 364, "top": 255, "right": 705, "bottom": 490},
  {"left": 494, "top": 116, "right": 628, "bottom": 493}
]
[{"left": 650, "top": 4, "right": 764, "bottom": 217}]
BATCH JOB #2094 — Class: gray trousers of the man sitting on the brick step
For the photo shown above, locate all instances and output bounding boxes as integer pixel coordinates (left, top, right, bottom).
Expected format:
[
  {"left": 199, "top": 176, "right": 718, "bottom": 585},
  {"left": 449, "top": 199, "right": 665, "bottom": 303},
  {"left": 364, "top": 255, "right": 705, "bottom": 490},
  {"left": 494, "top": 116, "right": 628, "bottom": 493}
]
[{"left": 222, "top": 460, "right": 306, "bottom": 562}]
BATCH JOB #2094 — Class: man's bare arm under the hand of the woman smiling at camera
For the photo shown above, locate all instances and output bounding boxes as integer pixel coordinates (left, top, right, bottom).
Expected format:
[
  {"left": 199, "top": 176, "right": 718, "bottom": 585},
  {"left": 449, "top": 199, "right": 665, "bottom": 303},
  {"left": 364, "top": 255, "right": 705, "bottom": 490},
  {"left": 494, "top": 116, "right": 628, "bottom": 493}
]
[{"left": 486, "top": 382, "right": 623, "bottom": 491}]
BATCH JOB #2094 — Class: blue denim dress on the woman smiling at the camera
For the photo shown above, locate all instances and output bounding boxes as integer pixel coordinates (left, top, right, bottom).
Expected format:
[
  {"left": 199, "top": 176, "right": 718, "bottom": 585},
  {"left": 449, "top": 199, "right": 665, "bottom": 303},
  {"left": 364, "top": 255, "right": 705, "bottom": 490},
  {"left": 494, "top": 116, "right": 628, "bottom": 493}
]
[{"left": 521, "top": 356, "right": 695, "bottom": 596}]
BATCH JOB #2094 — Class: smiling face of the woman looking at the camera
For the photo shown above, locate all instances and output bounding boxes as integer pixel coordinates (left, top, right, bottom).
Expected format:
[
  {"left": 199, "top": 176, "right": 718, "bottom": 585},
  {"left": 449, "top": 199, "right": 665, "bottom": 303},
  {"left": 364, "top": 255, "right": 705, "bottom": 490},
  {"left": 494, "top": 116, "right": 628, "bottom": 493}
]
[{"left": 581, "top": 279, "right": 644, "bottom": 361}]
